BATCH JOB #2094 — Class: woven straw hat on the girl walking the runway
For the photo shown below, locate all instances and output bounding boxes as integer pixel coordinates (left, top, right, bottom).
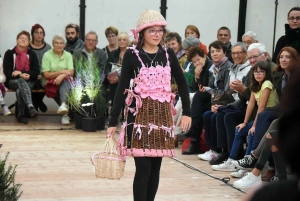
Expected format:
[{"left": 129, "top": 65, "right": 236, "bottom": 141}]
[{"left": 136, "top": 10, "right": 167, "bottom": 33}]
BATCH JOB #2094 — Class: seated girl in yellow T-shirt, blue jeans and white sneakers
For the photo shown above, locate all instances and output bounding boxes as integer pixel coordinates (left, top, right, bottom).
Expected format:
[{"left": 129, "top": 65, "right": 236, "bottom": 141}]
[{"left": 212, "top": 61, "right": 278, "bottom": 171}]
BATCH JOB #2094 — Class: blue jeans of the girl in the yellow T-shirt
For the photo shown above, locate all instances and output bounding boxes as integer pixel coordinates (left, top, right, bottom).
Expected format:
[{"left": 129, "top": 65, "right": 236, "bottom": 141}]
[{"left": 229, "top": 121, "right": 253, "bottom": 160}]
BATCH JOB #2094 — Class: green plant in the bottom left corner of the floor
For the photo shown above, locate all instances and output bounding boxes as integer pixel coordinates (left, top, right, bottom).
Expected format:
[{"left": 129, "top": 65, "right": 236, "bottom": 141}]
[{"left": 0, "top": 152, "right": 22, "bottom": 201}]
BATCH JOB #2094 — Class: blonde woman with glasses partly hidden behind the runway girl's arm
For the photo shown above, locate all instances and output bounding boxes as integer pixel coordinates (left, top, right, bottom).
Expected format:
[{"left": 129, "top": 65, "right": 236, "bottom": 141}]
[{"left": 105, "top": 32, "right": 130, "bottom": 105}]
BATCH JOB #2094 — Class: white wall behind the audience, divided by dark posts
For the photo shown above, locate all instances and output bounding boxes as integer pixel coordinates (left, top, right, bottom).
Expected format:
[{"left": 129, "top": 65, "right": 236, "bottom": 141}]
[{"left": 0, "top": 0, "right": 299, "bottom": 108}]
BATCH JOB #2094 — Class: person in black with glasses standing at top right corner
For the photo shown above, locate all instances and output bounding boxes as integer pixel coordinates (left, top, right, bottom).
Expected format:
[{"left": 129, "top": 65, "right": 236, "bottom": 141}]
[{"left": 272, "top": 7, "right": 300, "bottom": 63}]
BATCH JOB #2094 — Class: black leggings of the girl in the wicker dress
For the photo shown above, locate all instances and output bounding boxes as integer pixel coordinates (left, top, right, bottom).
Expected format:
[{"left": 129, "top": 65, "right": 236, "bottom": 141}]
[{"left": 133, "top": 157, "right": 162, "bottom": 201}]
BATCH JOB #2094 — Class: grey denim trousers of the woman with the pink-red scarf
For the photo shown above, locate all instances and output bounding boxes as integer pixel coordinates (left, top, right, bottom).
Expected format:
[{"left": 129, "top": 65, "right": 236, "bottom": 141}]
[{"left": 8, "top": 78, "right": 34, "bottom": 117}]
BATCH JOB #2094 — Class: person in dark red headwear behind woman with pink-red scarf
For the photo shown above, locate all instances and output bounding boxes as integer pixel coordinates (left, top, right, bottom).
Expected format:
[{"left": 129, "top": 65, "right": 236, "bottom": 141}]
[{"left": 29, "top": 24, "right": 51, "bottom": 112}]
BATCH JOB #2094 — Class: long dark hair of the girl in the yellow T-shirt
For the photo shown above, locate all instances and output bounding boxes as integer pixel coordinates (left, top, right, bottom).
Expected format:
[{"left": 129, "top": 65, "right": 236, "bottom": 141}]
[{"left": 250, "top": 60, "right": 275, "bottom": 93}]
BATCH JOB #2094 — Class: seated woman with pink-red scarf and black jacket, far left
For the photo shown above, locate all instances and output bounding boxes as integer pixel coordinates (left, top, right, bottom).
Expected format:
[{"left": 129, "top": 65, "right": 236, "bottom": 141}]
[{"left": 3, "top": 31, "right": 40, "bottom": 124}]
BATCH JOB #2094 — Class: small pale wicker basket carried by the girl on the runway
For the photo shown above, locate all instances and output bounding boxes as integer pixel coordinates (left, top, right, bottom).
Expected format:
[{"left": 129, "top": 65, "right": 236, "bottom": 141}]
[{"left": 91, "top": 135, "right": 126, "bottom": 180}]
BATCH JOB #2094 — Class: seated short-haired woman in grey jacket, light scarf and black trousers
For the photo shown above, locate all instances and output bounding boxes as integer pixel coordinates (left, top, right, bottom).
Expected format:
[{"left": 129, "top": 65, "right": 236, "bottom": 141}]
[{"left": 182, "top": 40, "right": 232, "bottom": 155}]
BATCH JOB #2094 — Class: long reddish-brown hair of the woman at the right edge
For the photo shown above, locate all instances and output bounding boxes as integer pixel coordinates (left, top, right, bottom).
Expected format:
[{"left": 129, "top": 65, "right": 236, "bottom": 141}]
[{"left": 275, "top": 47, "right": 300, "bottom": 72}]
